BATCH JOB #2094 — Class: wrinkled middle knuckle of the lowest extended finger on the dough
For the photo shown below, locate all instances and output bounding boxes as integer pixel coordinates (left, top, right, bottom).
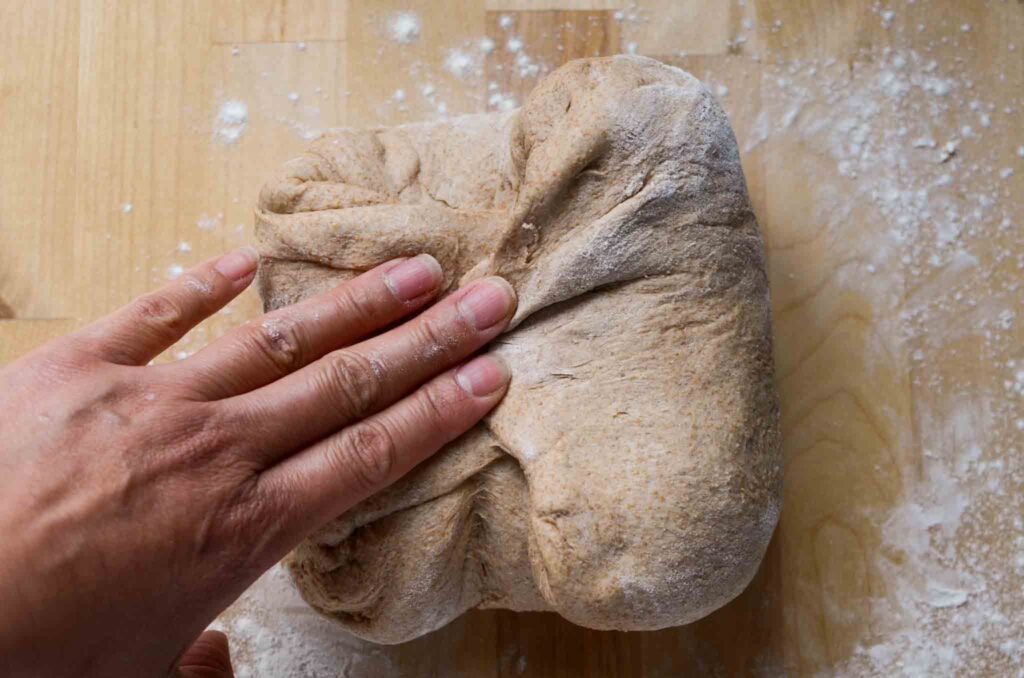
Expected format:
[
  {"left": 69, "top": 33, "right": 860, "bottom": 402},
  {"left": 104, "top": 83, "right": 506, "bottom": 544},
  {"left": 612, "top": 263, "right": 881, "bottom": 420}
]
[{"left": 329, "top": 421, "right": 397, "bottom": 493}]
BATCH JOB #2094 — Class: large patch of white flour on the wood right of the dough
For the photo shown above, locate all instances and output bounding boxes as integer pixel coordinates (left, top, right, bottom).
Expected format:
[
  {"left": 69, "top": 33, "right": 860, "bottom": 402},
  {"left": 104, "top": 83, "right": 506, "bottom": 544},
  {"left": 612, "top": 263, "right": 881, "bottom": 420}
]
[{"left": 713, "top": 45, "right": 1024, "bottom": 676}]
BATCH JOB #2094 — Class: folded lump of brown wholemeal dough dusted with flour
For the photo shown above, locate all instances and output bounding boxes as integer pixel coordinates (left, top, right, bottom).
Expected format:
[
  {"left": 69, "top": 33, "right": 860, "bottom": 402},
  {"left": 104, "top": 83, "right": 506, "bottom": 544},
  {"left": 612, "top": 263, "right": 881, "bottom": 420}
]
[{"left": 257, "top": 56, "right": 781, "bottom": 643}]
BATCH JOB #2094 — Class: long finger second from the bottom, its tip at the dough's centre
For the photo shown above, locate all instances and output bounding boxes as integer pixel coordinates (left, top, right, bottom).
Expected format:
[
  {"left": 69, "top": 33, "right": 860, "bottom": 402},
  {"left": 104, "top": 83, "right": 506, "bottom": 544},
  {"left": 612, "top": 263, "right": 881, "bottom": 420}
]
[{"left": 224, "top": 278, "right": 515, "bottom": 466}]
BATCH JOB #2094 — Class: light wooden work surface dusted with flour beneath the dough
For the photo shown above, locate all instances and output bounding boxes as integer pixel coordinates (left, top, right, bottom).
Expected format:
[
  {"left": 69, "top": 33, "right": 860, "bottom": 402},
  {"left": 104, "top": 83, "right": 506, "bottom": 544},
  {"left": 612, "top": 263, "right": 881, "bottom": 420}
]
[{"left": 0, "top": 0, "right": 1024, "bottom": 676}]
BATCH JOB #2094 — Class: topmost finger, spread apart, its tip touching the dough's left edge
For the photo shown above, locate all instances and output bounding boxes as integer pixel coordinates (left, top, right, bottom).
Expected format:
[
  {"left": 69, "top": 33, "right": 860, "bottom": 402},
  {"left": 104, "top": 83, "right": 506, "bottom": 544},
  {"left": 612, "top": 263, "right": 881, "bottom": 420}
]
[{"left": 73, "top": 247, "right": 258, "bottom": 365}]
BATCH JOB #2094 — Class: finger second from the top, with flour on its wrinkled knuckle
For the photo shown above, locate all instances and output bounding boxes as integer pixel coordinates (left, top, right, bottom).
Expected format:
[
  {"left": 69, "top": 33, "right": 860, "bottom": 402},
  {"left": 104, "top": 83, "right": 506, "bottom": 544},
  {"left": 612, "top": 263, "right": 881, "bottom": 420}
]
[{"left": 181, "top": 254, "right": 443, "bottom": 399}]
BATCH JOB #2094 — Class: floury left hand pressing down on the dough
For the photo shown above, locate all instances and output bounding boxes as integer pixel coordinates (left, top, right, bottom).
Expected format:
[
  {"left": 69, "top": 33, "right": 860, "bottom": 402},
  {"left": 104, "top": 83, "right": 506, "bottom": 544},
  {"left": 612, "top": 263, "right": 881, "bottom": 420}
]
[{"left": 0, "top": 250, "right": 515, "bottom": 676}]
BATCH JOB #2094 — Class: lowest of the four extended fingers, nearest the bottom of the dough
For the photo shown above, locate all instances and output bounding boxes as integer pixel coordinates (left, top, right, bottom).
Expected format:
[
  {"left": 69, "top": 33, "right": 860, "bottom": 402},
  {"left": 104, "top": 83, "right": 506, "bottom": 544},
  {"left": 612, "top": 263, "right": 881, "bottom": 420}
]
[{"left": 261, "top": 355, "right": 510, "bottom": 532}]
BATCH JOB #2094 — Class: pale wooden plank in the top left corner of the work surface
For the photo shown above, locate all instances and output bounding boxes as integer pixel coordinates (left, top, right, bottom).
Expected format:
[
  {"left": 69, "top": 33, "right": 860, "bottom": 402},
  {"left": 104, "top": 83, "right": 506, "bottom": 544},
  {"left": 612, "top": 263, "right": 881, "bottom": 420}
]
[{"left": 0, "top": 2, "right": 79, "bottom": 317}]
